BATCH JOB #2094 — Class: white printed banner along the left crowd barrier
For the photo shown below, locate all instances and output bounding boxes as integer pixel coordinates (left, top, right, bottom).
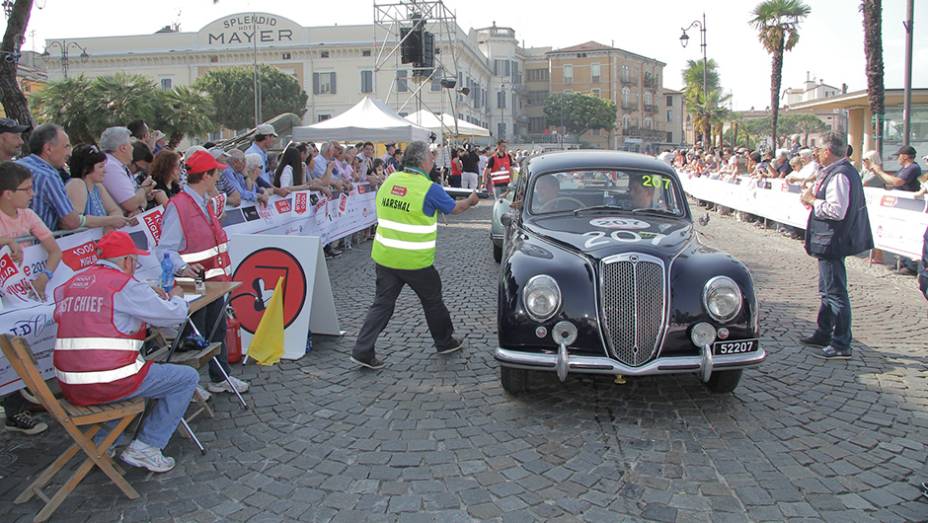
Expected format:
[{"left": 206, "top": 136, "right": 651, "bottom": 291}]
[{"left": 0, "top": 184, "right": 377, "bottom": 395}]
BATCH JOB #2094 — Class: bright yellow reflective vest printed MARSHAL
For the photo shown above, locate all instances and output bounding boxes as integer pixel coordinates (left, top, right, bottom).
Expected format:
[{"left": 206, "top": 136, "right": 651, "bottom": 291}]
[{"left": 371, "top": 171, "right": 438, "bottom": 270}]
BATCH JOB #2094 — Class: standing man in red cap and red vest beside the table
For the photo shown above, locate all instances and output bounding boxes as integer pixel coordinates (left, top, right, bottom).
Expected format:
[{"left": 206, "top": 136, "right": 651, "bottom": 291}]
[{"left": 158, "top": 151, "right": 248, "bottom": 392}]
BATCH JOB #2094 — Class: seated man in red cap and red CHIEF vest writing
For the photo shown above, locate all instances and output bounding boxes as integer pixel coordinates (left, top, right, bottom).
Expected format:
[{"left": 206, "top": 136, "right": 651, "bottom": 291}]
[{"left": 52, "top": 231, "right": 199, "bottom": 472}]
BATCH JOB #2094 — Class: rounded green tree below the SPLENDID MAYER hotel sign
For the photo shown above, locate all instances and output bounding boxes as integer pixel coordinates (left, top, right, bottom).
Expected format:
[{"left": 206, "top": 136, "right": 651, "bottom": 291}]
[{"left": 194, "top": 65, "right": 309, "bottom": 129}]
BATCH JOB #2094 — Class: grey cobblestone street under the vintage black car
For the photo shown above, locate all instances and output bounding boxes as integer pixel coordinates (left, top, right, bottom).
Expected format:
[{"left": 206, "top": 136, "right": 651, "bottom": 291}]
[{"left": 0, "top": 201, "right": 928, "bottom": 523}]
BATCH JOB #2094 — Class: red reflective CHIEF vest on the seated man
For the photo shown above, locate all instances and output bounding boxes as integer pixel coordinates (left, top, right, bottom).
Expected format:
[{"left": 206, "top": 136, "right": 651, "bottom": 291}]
[{"left": 52, "top": 265, "right": 151, "bottom": 405}]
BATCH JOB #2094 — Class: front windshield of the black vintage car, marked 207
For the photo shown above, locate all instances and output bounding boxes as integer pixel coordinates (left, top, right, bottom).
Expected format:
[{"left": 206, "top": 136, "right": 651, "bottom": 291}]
[{"left": 528, "top": 169, "right": 683, "bottom": 216}]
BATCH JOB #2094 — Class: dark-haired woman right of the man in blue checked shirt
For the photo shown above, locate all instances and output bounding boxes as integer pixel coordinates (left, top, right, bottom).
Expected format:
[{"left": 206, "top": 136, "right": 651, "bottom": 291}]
[{"left": 64, "top": 145, "right": 131, "bottom": 229}]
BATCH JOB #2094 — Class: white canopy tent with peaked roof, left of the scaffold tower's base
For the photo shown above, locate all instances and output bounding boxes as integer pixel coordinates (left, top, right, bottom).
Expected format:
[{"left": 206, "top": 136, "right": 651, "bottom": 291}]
[{"left": 293, "top": 96, "right": 431, "bottom": 143}]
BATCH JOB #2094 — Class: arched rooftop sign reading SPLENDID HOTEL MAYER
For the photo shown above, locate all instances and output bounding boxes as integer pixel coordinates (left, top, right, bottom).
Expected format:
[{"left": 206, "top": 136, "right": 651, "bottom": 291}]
[{"left": 199, "top": 13, "right": 305, "bottom": 47}]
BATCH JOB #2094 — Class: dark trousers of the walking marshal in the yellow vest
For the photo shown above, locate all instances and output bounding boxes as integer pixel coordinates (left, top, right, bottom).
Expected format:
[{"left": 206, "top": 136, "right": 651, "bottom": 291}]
[{"left": 351, "top": 264, "right": 454, "bottom": 361}]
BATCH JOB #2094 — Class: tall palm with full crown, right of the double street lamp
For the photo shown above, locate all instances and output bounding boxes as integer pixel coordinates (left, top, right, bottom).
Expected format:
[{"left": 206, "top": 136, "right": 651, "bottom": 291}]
[{"left": 750, "top": 0, "right": 812, "bottom": 147}]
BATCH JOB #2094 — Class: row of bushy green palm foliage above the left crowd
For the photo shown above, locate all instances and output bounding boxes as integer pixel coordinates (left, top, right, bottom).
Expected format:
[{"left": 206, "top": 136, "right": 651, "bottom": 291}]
[{"left": 32, "top": 74, "right": 218, "bottom": 143}]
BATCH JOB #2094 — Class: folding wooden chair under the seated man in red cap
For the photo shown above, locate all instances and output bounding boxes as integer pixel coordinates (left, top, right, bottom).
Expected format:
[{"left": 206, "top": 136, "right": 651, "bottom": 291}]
[{"left": 0, "top": 334, "right": 145, "bottom": 522}]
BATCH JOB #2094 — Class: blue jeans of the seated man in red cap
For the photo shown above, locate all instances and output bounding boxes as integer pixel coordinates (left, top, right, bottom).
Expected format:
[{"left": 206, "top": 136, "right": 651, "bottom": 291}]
[{"left": 93, "top": 363, "right": 200, "bottom": 449}]
